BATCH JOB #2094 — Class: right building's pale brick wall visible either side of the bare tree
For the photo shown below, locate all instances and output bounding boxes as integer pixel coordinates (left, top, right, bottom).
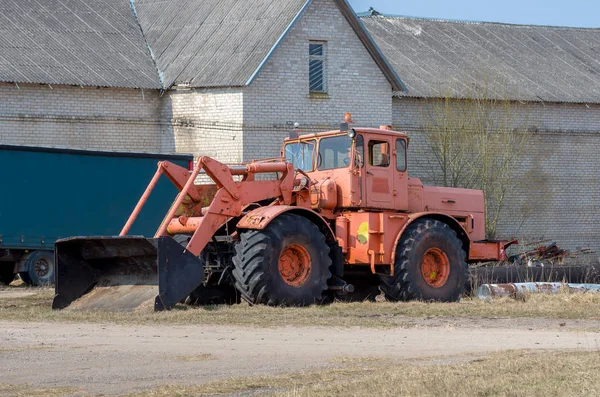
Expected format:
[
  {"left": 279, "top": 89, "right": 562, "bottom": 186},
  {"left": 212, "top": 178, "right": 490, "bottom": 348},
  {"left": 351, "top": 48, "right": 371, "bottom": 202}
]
[{"left": 393, "top": 98, "right": 600, "bottom": 260}]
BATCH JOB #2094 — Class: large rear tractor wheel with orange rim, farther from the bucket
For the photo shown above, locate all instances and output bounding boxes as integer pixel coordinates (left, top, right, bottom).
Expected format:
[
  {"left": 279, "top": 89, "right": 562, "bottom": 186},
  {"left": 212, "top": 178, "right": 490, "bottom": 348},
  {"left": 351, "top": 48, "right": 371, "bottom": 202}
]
[{"left": 380, "top": 219, "right": 468, "bottom": 302}]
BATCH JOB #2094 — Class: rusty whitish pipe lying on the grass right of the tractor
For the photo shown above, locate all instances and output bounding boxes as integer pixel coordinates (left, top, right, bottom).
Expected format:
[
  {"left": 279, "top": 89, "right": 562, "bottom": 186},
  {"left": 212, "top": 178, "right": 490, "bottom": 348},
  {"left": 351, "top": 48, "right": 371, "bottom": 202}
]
[{"left": 477, "top": 283, "right": 600, "bottom": 300}]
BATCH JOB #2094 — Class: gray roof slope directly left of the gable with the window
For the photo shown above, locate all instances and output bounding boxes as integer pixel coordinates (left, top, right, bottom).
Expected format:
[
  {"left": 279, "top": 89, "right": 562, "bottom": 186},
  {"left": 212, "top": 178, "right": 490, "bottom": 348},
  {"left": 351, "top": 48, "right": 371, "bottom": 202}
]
[{"left": 135, "top": 0, "right": 307, "bottom": 87}]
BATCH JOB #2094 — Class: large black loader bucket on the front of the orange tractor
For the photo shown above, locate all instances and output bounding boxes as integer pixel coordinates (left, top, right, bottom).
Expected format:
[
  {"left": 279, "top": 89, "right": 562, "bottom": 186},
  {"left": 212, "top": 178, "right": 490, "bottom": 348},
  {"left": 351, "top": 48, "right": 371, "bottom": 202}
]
[{"left": 52, "top": 237, "right": 209, "bottom": 311}]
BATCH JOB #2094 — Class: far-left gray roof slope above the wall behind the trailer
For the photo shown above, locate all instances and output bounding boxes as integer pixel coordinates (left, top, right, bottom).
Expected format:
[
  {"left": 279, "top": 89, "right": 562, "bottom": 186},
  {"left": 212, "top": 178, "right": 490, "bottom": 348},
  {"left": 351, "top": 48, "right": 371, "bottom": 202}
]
[{"left": 0, "top": 0, "right": 160, "bottom": 88}]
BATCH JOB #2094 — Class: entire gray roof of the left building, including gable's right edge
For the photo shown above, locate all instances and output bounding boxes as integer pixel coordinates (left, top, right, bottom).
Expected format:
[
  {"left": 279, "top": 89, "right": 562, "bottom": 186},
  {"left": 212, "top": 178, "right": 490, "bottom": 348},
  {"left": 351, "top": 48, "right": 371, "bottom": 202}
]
[{"left": 0, "top": 0, "right": 404, "bottom": 91}]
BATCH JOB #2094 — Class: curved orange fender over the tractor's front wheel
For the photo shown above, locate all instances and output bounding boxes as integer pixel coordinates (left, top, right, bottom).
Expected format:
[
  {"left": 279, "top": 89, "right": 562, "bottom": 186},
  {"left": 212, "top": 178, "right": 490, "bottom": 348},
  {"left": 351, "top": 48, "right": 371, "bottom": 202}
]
[{"left": 237, "top": 205, "right": 336, "bottom": 245}]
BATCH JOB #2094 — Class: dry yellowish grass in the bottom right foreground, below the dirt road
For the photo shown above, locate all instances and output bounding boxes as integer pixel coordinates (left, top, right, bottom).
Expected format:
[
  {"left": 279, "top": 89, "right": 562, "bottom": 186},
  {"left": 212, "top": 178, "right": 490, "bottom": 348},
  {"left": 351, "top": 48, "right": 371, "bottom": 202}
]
[{"left": 123, "top": 351, "right": 600, "bottom": 397}]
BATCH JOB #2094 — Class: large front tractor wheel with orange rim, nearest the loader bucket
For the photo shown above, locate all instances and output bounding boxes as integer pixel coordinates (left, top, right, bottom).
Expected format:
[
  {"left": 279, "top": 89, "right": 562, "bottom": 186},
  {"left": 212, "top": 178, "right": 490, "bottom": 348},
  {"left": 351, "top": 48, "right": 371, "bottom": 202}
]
[{"left": 233, "top": 214, "right": 331, "bottom": 306}]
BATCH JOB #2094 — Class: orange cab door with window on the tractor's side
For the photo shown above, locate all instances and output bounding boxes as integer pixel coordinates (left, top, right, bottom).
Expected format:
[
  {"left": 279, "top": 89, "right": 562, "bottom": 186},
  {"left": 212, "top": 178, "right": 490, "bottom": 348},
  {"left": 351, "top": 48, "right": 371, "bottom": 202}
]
[{"left": 365, "top": 137, "right": 396, "bottom": 208}]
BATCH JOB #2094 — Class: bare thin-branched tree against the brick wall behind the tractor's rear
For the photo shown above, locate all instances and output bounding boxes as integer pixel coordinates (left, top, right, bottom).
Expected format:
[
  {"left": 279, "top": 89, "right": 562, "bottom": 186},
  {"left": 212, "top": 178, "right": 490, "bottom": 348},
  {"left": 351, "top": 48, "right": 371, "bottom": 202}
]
[{"left": 423, "top": 87, "right": 531, "bottom": 238}]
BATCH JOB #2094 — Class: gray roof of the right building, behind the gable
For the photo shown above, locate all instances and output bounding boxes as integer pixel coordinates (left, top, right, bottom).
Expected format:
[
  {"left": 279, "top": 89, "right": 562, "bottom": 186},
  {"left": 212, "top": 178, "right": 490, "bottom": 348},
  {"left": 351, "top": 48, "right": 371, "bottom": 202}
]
[{"left": 361, "top": 11, "right": 600, "bottom": 103}]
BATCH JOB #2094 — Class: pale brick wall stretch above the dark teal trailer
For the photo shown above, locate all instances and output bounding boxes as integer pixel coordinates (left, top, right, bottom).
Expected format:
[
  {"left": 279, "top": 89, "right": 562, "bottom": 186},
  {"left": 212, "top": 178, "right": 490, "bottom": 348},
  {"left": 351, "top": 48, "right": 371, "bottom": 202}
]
[{"left": 0, "top": 83, "right": 169, "bottom": 153}]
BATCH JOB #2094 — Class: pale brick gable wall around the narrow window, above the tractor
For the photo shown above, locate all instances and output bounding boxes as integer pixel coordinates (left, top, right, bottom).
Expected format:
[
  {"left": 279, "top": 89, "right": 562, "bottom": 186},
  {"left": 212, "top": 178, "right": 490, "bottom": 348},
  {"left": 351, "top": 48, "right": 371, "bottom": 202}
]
[{"left": 243, "top": 0, "right": 392, "bottom": 160}]
